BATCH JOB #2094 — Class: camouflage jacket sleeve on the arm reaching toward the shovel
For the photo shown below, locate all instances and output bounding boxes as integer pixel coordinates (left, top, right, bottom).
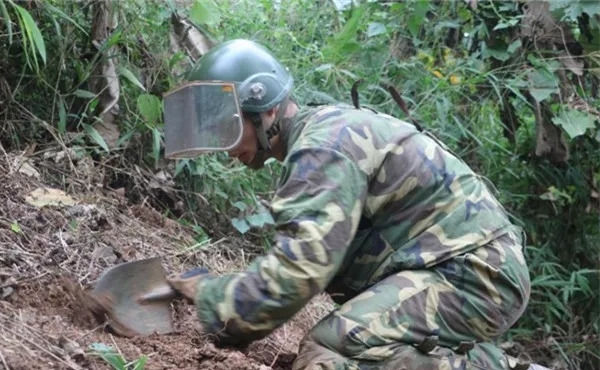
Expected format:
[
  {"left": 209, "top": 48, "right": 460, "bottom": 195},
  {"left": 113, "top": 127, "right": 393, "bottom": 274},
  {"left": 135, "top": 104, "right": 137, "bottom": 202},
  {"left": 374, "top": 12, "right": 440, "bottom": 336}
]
[{"left": 195, "top": 148, "right": 367, "bottom": 344}]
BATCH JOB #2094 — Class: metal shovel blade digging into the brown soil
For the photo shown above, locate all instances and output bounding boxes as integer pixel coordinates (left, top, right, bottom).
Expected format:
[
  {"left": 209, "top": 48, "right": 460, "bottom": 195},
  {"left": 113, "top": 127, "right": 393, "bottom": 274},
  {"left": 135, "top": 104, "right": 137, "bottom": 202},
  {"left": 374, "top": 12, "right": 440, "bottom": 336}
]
[{"left": 91, "top": 257, "right": 175, "bottom": 337}]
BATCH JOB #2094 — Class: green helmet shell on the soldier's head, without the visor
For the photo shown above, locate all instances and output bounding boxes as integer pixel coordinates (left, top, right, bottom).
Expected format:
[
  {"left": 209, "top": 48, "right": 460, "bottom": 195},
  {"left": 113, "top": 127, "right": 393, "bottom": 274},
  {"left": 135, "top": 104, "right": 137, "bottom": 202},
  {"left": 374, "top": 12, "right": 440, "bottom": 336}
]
[{"left": 187, "top": 39, "right": 293, "bottom": 113}]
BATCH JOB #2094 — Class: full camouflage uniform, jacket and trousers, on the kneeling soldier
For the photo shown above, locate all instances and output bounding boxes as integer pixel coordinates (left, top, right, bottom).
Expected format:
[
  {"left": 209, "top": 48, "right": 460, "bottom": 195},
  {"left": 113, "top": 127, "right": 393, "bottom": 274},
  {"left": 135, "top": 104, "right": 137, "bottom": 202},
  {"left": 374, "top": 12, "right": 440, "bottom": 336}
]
[{"left": 196, "top": 106, "right": 529, "bottom": 369}]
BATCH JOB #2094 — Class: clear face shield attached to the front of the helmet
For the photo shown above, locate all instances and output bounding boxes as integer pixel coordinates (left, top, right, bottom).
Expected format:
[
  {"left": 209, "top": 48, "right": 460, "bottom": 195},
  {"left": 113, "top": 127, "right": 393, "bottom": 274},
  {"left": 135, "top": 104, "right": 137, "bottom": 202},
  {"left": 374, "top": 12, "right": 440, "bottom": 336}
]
[{"left": 164, "top": 81, "right": 243, "bottom": 158}]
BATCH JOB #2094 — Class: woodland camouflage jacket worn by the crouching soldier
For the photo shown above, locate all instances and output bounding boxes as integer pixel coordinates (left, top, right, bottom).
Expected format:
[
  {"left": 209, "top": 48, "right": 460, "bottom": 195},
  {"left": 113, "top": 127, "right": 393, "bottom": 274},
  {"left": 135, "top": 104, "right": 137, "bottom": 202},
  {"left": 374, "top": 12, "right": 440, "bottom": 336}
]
[{"left": 195, "top": 106, "right": 512, "bottom": 343}]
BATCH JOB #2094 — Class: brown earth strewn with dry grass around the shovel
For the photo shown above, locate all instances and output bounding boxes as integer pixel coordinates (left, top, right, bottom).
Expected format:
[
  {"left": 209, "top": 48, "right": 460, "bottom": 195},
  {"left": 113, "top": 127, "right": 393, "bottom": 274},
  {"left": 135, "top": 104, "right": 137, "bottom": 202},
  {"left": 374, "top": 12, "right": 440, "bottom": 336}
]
[{"left": 0, "top": 153, "right": 331, "bottom": 370}]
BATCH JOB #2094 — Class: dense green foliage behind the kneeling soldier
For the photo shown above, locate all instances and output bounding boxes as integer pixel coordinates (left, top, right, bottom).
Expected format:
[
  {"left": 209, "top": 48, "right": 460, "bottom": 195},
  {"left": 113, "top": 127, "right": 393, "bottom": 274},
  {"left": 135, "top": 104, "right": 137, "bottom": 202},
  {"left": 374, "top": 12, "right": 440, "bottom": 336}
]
[{"left": 0, "top": 0, "right": 600, "bottom": 368}]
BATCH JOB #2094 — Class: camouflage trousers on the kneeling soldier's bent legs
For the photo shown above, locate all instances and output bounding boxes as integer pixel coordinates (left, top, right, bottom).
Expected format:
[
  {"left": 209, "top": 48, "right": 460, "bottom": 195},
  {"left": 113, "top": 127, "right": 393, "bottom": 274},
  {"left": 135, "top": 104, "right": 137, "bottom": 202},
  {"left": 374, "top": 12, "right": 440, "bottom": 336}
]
[{"left": 293, "top": 233, "right": 530, "bottom": 370}]
